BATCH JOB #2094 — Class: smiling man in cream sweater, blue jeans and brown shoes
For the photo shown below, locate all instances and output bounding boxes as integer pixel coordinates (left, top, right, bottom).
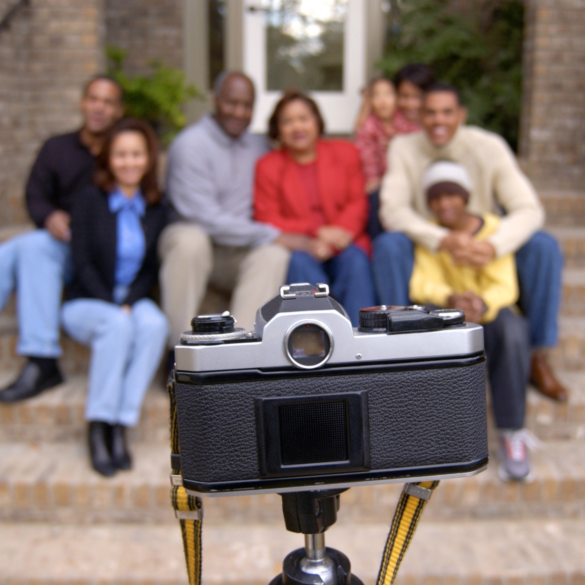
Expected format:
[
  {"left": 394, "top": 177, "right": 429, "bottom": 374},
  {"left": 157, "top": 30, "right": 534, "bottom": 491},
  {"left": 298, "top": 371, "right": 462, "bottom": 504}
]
[{"left": 373, "top": 83, "right": 568, "bottom": 401}]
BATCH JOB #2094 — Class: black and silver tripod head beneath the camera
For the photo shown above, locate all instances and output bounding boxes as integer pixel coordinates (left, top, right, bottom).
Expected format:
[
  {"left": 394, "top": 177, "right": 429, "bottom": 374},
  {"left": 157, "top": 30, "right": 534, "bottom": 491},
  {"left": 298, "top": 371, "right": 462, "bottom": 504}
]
[{"left": 270, "top": 489, "right": 363, "bottom": 585}]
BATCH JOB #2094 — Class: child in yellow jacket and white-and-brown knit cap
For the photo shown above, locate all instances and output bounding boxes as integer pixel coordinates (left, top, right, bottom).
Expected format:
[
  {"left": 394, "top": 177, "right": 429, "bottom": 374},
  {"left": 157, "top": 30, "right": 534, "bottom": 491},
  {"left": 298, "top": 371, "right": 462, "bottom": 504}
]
[{"left": 410, "top": 161, "right": 530, "bottom": 480}]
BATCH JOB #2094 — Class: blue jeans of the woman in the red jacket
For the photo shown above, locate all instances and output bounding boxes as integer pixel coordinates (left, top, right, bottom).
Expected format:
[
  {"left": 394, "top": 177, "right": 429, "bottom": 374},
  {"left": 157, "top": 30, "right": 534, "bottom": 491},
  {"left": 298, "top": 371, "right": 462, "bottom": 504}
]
[{"left": 286, "top": 244, "right": 376, "bottom": 327}]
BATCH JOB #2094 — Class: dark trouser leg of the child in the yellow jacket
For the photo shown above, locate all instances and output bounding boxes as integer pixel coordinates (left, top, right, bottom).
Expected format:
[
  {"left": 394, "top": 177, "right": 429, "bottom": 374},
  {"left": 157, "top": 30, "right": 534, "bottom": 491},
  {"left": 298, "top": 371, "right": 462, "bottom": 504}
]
[{"left": 483, "top": 309, "right": 530, "bottom": 430}]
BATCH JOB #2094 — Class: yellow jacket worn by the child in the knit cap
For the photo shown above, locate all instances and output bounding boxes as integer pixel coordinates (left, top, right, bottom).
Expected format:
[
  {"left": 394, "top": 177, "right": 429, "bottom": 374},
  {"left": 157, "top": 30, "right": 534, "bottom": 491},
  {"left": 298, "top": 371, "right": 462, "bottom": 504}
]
[{"left": 410, "top": 213, "right": 518, "bottom": 323}]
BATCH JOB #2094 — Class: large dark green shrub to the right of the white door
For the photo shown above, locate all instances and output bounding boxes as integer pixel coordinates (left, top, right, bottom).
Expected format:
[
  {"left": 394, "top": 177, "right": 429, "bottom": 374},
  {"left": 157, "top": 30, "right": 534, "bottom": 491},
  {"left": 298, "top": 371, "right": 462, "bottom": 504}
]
[{"left": 378, "top": 0, "right": 524, "bottom": 150}]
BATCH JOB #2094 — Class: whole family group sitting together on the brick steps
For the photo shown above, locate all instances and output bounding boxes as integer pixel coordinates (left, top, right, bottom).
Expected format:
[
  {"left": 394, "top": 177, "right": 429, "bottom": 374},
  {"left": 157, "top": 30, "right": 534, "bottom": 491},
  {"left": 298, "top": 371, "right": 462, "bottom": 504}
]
[{"left": 0, "top": 65, "right": 567, "bottom": 480}]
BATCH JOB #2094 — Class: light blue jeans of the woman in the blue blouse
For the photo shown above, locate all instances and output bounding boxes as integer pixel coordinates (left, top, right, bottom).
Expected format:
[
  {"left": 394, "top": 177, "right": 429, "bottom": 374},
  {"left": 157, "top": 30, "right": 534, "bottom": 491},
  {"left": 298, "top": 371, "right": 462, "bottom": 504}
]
[{"left": 62, "top": 299, "right": 169, "bottom": 426}]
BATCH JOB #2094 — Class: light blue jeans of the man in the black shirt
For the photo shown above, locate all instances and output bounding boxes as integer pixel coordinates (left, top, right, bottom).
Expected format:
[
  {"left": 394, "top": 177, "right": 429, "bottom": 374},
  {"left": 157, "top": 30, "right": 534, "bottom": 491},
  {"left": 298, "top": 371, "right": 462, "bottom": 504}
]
[{"left": 0, "top": 230, "right": 72, "bottom": 358}]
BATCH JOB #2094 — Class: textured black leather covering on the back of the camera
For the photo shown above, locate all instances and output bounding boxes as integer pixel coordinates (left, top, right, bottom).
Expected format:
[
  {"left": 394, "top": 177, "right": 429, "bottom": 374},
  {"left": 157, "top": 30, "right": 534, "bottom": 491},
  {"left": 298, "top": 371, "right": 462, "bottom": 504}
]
[{"left": 176, "top": 362, "right": 487, "bottom": 483}]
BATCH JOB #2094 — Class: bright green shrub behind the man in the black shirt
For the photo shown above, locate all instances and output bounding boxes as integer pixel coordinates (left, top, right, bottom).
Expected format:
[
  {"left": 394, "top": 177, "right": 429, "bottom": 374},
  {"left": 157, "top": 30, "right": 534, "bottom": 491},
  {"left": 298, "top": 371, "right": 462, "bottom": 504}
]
[{"left": 106, "top": 46, "right": 203, "bottom": 145}]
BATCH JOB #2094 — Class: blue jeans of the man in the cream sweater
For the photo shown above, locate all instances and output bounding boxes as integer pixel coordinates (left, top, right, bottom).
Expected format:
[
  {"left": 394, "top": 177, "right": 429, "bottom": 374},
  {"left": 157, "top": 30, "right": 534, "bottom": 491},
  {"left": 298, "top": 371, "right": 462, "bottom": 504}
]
[{"left": 373, "top": 232, "right": 563, "bottom": 348}]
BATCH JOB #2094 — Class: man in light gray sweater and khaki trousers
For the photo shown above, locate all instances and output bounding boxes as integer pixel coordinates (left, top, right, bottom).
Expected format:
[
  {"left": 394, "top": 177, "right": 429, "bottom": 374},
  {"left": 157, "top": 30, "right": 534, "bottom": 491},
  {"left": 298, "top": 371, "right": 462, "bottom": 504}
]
[{"left": 159, "top": 72, "right": 289, "bottom": 347}]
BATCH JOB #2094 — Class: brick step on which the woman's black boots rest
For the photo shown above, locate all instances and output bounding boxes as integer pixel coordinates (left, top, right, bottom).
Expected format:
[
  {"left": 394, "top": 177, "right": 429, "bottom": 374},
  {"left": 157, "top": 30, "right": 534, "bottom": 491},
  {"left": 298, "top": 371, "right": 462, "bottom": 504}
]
[{"left": 0, "top": 441, "right": 585, "bottom": 524}]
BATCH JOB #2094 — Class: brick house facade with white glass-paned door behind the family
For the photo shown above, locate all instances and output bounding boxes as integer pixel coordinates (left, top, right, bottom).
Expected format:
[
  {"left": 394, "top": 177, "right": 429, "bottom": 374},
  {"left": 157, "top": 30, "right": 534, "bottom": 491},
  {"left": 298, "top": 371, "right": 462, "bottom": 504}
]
[{"left": 0, "top": 0, "right": 585, "bottom": 227}]
